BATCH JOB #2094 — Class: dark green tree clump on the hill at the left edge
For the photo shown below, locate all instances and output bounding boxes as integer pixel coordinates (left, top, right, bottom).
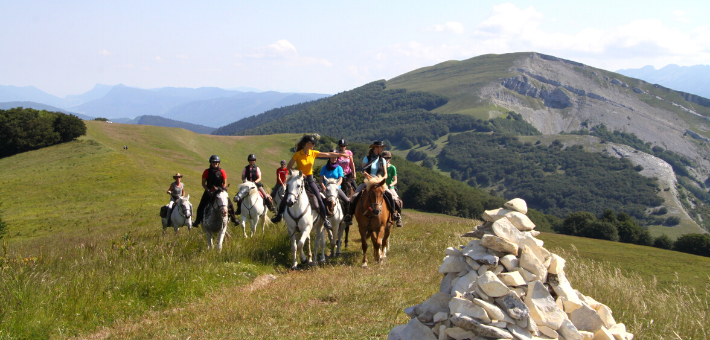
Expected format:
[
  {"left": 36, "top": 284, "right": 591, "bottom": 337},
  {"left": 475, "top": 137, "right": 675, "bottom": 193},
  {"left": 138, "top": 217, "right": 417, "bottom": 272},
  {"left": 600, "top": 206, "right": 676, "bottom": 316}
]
[{"left": 0, "top": 107, "right": 86, "bottom": 158}]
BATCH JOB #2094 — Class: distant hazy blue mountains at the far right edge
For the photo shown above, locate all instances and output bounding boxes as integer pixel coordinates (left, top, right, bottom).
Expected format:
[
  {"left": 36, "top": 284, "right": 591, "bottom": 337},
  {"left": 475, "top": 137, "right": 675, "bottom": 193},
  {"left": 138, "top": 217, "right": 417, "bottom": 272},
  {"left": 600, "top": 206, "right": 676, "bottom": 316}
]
[{"left": 616, "top": 64, "right": 710, "bottom": 98}]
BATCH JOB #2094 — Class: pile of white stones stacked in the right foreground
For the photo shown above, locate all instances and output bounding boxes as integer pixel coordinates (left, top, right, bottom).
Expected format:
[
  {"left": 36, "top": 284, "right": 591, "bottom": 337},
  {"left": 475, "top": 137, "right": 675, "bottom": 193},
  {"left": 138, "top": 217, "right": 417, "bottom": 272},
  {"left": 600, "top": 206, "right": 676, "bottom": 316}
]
[{"left": 388, "top": 198, "right": 633, "bottom": 340}]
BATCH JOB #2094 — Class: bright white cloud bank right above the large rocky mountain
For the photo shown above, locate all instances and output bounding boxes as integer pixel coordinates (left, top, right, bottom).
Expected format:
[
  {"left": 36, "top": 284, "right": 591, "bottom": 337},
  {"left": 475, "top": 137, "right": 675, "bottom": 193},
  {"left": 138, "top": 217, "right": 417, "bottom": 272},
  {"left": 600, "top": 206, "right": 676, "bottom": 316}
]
[{"left": 382, "top": 3, "right": 710, "bottom": 70}]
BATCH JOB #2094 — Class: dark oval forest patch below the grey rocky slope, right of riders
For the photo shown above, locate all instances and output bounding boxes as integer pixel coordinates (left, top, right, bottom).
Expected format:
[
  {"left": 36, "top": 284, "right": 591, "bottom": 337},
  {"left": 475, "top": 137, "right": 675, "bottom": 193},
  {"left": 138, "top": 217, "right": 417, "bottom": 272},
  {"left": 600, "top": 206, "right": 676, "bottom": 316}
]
[{"left": 439, "top": 133, "right": 663, "bottom": 221}]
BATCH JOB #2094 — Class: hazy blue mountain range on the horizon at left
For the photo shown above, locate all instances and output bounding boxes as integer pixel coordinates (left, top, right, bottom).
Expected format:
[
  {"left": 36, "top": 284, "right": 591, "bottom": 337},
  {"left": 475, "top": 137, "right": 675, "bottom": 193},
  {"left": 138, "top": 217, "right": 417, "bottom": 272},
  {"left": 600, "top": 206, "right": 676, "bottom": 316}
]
[{"left": 0, "top": 84, "right": 328, "bottom": 127}]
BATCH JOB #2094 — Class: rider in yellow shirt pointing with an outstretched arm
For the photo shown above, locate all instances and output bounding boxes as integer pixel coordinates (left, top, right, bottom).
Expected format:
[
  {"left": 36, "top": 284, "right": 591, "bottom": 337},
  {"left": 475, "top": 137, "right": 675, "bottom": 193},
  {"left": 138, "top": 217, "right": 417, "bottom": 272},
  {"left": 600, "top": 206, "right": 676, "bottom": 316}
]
[{"left": 271, "top": 135, "right": 345, "bottom": 229}]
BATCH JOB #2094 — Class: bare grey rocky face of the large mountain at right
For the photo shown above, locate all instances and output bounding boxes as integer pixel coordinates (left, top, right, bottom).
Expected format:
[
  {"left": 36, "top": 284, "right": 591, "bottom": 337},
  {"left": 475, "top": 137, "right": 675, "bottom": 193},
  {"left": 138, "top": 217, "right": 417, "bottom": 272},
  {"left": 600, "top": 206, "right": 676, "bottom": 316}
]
[{"left": 479, "top": 53, "right": 710, "bottom": 180}]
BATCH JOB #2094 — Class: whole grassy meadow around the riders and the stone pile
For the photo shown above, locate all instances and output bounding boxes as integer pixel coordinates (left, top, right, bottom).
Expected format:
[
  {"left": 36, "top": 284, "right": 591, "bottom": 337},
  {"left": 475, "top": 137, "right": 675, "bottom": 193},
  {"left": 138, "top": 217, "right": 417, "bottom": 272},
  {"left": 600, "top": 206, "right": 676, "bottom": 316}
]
[{"left": 0, "top": 122, "right": 710, "bottom": 339}]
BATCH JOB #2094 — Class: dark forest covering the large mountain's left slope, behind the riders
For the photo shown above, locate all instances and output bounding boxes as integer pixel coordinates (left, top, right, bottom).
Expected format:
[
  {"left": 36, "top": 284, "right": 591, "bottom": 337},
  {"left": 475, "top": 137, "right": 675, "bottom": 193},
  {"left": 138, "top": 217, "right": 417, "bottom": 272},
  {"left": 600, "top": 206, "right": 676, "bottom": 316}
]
[{"left": 213, "top": 81, "right": 539, "bottom": 145}]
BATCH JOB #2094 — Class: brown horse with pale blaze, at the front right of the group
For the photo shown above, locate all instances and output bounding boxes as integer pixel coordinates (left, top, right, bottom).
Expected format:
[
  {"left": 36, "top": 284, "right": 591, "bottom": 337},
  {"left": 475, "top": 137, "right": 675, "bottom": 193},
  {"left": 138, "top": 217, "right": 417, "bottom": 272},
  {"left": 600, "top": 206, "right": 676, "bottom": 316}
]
[{"left": 355, "top": 175, "right": 392, "bottom": 267}]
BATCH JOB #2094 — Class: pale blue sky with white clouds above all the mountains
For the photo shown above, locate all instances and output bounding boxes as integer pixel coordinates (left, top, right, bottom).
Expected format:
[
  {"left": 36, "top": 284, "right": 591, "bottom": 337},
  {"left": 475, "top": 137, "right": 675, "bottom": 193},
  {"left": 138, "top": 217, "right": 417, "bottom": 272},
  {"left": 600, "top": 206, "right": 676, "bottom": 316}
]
[{"left": 0, "top": 0, "right": 710, "bottom": 97}]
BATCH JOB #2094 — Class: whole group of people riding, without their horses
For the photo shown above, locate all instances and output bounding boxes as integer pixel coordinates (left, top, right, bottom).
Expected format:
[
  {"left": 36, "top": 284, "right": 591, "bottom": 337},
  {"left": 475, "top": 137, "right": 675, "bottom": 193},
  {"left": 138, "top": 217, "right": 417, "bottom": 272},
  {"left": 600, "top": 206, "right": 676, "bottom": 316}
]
[{"left": 168, "top": 135, "right": 402, "bottom": 229}]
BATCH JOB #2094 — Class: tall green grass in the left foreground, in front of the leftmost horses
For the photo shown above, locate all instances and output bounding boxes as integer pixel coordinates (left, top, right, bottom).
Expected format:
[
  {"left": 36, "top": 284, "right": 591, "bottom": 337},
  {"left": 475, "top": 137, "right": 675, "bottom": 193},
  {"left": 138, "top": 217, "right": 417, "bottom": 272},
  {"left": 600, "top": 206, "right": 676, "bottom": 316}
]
[{"left": 0, "top": 227, "right": 288, "bottom": 339}]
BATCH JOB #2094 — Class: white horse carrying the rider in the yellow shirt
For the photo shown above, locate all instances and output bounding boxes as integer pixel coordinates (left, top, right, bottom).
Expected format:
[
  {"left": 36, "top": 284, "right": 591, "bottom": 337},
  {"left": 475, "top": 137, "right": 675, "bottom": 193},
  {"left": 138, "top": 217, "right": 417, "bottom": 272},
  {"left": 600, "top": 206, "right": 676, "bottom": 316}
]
[{"left": 284, "top": 170, "right": 318, "bottom": 270}]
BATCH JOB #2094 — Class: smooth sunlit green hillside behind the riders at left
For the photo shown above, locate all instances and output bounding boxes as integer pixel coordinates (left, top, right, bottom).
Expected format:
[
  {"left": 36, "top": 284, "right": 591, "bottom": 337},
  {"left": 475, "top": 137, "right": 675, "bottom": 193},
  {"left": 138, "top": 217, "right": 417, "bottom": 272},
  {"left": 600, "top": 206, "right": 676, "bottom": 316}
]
[{"left": 0, "top": 122, "right": 296, "bottom": 244}]
